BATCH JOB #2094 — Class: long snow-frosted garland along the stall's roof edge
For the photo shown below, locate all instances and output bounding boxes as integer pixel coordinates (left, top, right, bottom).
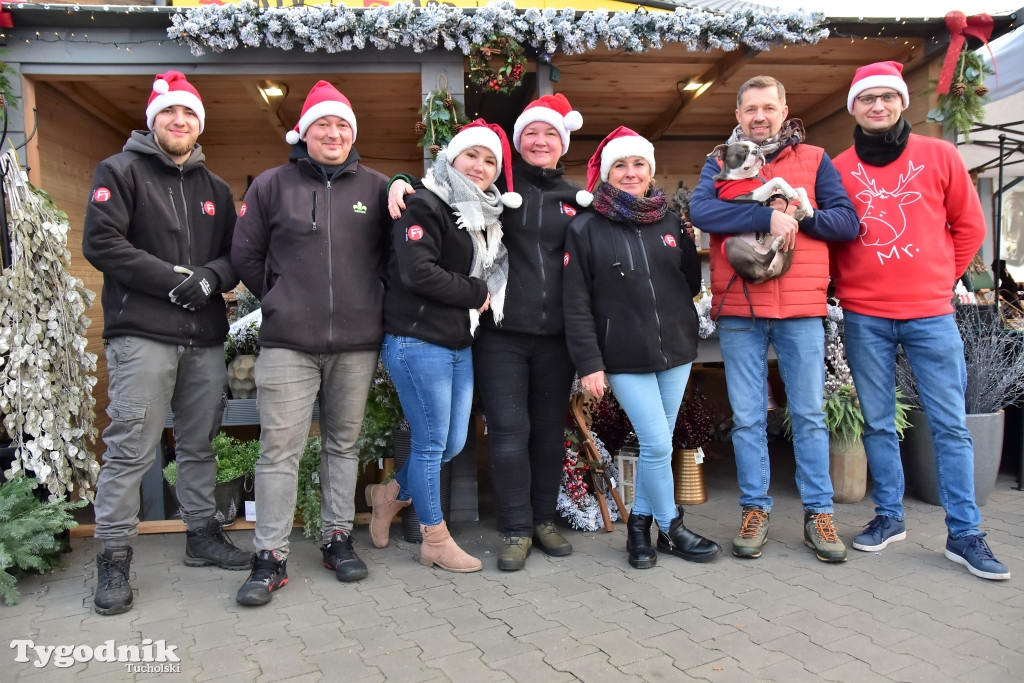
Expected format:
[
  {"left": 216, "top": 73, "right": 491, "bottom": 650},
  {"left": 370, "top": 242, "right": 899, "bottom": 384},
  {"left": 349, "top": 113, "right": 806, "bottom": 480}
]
[{"left": 167, "top": 0, "right": 828, "bottom": 55}]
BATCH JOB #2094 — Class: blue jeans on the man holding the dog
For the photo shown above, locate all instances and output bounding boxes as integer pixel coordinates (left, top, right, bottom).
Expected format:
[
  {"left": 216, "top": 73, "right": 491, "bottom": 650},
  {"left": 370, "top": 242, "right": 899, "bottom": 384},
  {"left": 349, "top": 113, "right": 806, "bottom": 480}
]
[{"left": 718, "top": 316, "right": 833, "bottom": 513}]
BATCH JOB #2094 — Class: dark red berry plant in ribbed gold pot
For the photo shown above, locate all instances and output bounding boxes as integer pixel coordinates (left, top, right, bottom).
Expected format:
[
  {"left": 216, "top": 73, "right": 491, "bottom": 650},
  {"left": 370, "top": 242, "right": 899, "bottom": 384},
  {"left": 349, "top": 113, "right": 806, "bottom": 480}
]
[{"left": 672, "top": 389, "right": 718, "bottom": 505}]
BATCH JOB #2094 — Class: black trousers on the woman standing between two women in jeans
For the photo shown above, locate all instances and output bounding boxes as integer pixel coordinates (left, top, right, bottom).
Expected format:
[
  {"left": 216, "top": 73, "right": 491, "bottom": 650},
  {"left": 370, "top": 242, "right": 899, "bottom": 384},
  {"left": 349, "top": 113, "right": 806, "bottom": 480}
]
[{"left": 473, "top": 329, "right": 575, "bottom": 537}]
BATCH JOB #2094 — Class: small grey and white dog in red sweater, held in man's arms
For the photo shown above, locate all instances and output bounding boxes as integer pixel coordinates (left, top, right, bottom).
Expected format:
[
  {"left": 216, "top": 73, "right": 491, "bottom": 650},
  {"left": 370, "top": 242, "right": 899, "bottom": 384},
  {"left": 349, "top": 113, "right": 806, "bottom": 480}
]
[{"left": 708, "top": 140, "right": 814, "bottom": 285}]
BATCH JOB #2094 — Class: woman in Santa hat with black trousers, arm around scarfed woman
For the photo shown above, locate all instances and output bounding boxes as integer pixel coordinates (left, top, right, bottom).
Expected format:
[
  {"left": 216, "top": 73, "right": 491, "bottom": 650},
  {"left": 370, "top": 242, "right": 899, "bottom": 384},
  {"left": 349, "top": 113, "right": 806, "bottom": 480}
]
[{"left": 375, "top": 94, "right": 586, "bottom": 571}]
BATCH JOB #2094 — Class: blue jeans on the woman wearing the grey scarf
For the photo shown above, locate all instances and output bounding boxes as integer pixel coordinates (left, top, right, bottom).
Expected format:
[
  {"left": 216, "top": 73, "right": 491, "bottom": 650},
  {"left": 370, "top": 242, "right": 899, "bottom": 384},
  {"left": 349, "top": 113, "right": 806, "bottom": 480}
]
[{"left": 381, "top": 334, "right": 473, "bottom": 526}]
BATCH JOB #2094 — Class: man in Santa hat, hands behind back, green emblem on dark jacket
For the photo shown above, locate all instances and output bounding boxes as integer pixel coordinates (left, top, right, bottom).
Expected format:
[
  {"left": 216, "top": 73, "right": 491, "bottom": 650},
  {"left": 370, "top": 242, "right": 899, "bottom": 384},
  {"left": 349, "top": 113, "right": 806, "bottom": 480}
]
[{"left": 231, "top": 81, "right": 391, "bottom": 605}]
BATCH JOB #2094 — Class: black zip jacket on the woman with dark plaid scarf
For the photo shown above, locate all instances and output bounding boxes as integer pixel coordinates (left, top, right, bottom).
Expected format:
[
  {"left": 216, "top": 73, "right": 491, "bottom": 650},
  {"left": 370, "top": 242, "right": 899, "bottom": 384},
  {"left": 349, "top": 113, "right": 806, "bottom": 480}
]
[{"left": 563, "top": 211, "right": 700, "bottom": 377}]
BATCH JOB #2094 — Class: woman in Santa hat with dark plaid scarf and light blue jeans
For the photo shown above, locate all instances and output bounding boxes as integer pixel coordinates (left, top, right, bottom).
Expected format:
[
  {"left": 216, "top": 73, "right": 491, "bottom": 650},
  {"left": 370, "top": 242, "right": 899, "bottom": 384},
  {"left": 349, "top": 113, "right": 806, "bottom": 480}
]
[{"left": 563, "top": 126, "right": 722, "bottom": 569}]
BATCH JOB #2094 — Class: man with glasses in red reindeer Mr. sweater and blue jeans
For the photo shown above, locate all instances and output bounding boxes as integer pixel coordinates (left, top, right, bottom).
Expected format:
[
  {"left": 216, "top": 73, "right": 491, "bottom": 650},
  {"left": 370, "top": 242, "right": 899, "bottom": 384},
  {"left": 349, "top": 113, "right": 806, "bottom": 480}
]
[{"left": 830, "top": 61, "right": 1010, "bottom": 580}]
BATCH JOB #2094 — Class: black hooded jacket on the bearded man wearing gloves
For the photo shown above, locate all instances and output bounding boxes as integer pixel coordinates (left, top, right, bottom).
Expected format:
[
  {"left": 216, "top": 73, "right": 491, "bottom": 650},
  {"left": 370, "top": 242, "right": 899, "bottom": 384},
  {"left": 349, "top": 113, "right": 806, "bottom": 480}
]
[{"left": 82, "top": 130, "right": 239, "bottom": 346}]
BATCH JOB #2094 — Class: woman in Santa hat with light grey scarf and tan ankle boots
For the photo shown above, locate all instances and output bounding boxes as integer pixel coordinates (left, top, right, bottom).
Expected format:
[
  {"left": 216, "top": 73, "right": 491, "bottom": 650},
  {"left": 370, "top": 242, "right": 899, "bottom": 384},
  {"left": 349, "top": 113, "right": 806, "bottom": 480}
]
[{"left": 367, "top": 119, "right": 521, "bottom": 571}]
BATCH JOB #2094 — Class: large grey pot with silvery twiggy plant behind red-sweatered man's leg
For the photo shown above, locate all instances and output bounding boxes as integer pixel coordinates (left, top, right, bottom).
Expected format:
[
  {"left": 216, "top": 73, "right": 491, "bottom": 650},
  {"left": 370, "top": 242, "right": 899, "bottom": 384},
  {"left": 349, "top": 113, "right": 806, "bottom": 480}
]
[{"left": 896, "top": 299, "right": 1024, "bottom": 506}]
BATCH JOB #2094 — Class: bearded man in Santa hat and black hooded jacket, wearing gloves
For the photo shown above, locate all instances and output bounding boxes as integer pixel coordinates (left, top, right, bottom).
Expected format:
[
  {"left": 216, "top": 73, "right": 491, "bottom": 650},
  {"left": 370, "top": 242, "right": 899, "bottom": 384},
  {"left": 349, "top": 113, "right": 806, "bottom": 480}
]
[{"left": 82, "top": 71, "right": 245, "bottom": 614}]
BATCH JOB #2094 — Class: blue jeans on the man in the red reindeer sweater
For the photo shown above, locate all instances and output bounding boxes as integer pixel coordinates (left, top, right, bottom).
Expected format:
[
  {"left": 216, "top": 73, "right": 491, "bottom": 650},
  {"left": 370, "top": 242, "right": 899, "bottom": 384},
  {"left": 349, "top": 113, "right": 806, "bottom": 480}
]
[{"left": 844, "top": 311, "right": 981, "bottom": 539}]
